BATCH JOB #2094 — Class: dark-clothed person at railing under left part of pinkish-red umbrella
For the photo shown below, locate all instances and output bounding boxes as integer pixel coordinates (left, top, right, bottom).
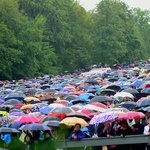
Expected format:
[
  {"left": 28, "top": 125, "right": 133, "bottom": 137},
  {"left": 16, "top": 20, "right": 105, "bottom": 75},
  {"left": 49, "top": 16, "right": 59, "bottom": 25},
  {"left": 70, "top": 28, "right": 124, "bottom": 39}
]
[{"left": 116, "top": 120, "right": 132, "bottom": 150}]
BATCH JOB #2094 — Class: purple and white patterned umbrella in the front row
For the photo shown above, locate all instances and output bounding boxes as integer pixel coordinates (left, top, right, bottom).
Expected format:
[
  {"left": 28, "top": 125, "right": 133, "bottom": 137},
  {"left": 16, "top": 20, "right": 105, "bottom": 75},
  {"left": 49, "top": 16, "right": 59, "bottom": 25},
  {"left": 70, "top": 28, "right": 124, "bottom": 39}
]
[{"left": 90, "top": 112, "right": 118, "bottom": 124}]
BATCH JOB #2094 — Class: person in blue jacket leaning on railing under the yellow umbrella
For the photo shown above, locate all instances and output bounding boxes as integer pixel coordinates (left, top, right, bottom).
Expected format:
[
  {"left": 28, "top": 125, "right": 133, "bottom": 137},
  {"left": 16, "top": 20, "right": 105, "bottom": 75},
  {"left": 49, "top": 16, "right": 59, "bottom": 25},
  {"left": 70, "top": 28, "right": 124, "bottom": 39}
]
[{"left": 68, "top": 123, "right": 85, "bottom": 140}]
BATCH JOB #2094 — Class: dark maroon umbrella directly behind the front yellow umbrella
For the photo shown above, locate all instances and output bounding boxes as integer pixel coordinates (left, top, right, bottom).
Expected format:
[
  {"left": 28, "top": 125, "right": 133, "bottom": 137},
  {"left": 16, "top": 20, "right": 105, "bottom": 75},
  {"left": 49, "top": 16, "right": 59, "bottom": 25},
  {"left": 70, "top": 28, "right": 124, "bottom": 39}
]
[{"left": 66, "top": 112, "right": 91, "bottom": 121}]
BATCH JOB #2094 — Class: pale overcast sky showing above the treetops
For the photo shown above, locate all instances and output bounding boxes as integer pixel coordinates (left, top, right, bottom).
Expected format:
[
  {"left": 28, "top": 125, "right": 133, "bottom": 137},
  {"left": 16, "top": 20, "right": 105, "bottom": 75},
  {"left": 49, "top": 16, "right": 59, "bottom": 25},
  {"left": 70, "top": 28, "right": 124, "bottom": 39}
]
[{"left": 78, "top": 0, "right": 150, "bottom": 10}]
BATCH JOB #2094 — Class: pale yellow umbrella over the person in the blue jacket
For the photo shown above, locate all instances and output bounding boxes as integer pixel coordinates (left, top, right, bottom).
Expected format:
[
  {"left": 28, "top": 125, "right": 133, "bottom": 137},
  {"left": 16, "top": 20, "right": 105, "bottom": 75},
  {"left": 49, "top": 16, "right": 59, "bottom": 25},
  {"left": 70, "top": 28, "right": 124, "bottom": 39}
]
[{"left": 60, "top": 117, "right": 88, "bottom": 127}]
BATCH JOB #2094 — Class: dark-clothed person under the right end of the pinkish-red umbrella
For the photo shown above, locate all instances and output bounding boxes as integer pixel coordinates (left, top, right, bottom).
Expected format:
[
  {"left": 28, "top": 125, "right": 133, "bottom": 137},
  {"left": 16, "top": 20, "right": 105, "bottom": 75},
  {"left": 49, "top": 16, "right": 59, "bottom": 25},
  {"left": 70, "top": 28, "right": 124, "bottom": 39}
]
[{"left": 131, "top": 117, "right": 145, "bottom": 150}]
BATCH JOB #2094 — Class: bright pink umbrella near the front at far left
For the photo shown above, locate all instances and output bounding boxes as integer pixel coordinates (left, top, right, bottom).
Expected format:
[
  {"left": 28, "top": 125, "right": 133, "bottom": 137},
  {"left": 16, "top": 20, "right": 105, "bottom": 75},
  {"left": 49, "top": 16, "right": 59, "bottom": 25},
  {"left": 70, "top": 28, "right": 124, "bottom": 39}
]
[{"left": 15, "top": 116, "right": 39, "bottom": 123}]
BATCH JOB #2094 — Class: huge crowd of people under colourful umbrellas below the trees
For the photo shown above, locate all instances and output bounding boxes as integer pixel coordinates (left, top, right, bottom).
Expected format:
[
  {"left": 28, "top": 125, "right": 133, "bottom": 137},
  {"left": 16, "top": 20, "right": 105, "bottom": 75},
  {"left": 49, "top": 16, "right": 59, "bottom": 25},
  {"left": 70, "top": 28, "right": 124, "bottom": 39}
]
[{"left": 0, "top": 61, "right": 150, "bottom": 150}]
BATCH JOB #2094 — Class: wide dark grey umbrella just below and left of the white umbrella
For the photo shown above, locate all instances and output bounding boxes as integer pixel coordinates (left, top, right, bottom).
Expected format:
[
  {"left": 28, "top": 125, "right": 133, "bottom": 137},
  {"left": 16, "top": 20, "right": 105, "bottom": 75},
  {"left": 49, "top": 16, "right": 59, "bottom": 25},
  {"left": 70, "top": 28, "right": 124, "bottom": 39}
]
[{"left": 91, "top": 96, "right": 113, "bottom": 102}]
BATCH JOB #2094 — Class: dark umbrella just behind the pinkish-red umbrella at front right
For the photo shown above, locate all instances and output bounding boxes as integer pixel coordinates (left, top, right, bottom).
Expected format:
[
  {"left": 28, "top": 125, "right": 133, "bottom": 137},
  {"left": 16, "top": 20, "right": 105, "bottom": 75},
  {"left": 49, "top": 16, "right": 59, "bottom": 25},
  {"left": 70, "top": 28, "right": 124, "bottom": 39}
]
[{"left": 115, "top": 101, "right": 137, "bottom": 110}]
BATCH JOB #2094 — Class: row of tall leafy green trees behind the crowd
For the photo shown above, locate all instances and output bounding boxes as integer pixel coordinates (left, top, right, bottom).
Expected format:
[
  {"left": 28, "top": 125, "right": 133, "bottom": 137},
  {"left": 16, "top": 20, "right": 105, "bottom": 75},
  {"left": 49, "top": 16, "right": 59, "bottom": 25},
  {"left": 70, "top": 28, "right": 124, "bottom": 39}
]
[{"left": 0, "top": 0, "right": 150, "bottom": 79}]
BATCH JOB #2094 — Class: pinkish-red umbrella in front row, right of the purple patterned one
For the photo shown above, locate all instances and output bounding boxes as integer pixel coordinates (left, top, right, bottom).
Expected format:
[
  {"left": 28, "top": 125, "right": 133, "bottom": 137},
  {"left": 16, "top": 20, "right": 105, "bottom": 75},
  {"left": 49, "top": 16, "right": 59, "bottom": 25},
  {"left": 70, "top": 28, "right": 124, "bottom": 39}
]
[{"left": 118, "top": 111, "right": 145, "bottom": 120}]
